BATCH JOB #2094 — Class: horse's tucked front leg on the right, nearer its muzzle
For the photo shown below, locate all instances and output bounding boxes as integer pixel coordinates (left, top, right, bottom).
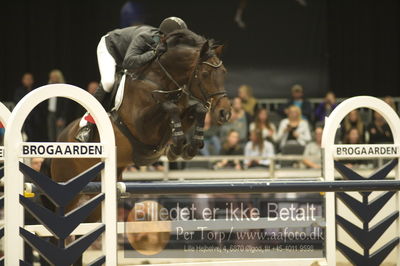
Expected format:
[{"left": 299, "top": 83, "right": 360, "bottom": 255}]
[{"left": 182, "top": 103, "right": 207, "bottom": 160}]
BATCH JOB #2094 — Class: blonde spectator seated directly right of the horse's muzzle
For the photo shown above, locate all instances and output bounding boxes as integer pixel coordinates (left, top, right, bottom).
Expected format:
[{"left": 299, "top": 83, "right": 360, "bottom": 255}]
[{"left": 220, "top": 97, "right": 251, "bottom": 144}]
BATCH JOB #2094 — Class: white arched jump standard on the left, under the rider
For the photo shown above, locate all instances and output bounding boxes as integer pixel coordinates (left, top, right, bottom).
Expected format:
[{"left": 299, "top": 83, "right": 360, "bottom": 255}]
[{"left": 4, "top": 84, "right": 117, "bottom": 266}]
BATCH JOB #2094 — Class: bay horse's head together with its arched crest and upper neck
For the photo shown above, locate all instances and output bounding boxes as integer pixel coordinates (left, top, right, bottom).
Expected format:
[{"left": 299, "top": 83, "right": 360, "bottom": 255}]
[{"left": 159, "top": 29, "right": 231, "bottom": 124}]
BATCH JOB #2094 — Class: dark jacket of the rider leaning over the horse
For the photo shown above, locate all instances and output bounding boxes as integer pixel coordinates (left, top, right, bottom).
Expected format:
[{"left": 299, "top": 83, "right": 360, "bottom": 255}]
[{"left": 105, "top": 25, "right": 160, "bottom": 69}]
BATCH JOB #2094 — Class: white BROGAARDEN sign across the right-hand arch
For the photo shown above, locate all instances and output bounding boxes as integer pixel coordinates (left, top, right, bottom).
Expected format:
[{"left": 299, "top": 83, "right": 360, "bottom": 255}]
[{"left": 333, "top": 144, "right": 400, "bottom": 159}]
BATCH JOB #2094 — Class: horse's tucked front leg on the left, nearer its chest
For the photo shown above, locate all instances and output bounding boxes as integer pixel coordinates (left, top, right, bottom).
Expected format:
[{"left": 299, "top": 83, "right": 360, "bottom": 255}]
[{"left": 161, "top": 101, "right": 185, "bottom": 161}]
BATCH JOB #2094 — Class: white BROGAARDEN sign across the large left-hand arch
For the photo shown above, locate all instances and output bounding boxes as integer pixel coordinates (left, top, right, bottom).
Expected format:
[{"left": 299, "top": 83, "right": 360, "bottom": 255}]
[{"left": 19, "top": 142, "right": 107, "bottom": 158}]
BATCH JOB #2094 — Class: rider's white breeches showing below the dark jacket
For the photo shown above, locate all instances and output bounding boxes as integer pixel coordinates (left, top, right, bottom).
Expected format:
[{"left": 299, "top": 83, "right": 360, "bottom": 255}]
[{"left": 97, "top": 35, "right": 116, "bottom": 92}]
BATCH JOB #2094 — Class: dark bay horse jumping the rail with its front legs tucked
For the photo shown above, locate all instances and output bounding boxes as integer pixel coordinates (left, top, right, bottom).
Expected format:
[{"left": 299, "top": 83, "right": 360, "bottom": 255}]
[{"left": 51, "top": 30, "right": 231, "bottom": 218}]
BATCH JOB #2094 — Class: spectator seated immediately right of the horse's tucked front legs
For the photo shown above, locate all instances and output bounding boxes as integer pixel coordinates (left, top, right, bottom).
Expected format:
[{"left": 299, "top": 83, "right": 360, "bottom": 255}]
[{"left": 200, "top": 112, "right": 221, "bottom": 156}]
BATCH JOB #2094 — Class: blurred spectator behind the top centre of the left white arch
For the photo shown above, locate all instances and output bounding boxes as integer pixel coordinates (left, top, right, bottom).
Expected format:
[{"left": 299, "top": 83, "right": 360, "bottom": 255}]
[{"left": 47, "top": 69, "right": 67, "bottom": 141}]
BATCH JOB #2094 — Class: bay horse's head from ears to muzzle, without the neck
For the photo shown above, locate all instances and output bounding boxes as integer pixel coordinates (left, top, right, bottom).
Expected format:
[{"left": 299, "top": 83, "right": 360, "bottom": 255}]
[{"left": 188, "top": 41, "right": 231, "bottom": 124}]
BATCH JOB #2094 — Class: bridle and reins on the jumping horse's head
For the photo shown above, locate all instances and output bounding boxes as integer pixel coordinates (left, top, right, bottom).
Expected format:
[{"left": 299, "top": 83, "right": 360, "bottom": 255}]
[{"left": 156, "top": 54, "right": 228, "bottom": 110}]
